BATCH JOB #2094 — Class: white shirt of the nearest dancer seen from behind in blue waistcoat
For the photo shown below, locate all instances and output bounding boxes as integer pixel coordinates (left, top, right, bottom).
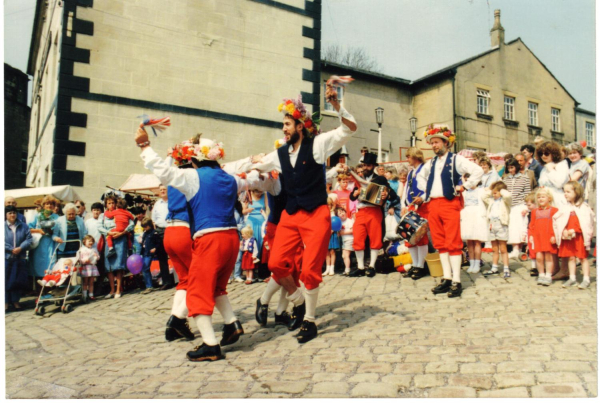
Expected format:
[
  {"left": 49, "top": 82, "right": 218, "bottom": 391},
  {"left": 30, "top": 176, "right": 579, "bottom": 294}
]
[{"left": 140, "top": 147, "right": 267, "bottom": 239}]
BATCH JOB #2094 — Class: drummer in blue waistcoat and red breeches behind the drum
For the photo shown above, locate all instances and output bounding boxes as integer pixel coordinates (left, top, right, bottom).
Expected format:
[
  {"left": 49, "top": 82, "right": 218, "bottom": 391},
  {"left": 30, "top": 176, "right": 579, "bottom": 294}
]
[{"left": 400, "top": 147, "right": 429, "bottom": 280}]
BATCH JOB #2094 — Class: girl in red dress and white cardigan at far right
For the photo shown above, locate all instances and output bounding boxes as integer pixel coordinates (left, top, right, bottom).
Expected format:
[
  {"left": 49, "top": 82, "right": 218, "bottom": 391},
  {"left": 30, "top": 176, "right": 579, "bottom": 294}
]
[{"left": 552, "top": 181, "right": 595, "bottom": 289}]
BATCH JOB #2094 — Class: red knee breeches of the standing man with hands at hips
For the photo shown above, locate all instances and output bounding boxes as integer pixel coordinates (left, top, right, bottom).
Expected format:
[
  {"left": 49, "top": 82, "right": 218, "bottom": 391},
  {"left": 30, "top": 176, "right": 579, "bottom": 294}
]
[{"left": 419, "top": 197, "right": 463, "bottom": 256}]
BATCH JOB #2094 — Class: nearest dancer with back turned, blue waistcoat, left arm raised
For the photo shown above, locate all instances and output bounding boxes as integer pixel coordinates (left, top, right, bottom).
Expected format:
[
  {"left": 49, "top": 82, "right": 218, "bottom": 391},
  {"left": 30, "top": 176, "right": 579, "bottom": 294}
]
[{"left": 135, "top": 129, "right": 270, "bottom": 361}]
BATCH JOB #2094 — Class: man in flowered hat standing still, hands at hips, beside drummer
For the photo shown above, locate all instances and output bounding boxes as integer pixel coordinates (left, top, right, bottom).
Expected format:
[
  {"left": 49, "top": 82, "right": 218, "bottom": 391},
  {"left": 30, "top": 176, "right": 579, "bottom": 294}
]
[{"left": 417, "top": 125, "right": 483, "bottom": 298}]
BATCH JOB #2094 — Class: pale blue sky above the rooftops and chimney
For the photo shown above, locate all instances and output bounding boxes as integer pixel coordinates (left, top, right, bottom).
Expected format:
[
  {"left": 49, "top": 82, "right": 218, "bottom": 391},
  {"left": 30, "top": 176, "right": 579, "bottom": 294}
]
[{"left": 4, "top": 0, "right": 596, "bottom": 111}]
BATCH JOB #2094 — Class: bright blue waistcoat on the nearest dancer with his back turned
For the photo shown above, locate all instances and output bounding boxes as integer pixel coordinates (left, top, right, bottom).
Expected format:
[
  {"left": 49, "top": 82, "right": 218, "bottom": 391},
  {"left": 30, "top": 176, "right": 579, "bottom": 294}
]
[{"left": 189, "top": 167, "right": 237, "bottom": 233}]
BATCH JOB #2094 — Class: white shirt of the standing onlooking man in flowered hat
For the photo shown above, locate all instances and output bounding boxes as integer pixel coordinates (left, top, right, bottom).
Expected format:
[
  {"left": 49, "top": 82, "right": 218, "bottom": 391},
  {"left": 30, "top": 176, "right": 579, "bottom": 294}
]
[{"left": 417, "top": 153, "right": 483, "bottom": 199}]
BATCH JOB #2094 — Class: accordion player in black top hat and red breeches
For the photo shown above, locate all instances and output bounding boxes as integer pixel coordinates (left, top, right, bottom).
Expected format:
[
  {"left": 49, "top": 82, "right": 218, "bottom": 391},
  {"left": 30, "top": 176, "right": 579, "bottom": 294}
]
[{"left": 348, "top": 153, "right": 400, "bottom": 277}]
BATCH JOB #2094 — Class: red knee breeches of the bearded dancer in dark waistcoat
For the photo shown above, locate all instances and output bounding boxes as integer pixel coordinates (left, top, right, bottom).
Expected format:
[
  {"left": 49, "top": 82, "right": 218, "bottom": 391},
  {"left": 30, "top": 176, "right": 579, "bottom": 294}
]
[{"left": 269, "top": 206, "right": 331, "bottom": 290}]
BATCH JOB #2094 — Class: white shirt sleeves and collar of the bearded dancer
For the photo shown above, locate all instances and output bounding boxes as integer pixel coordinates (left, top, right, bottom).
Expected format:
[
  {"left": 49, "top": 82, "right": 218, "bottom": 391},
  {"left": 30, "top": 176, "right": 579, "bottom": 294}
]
[{"left": 252, "top": 108, "right": 356, "bottom": 172}]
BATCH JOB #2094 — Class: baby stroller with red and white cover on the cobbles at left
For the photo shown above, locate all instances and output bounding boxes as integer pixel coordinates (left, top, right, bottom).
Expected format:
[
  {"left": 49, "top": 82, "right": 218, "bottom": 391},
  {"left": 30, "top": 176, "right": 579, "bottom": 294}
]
[{"left": 34, "top": 239, "right": 83, "bottom": 316}]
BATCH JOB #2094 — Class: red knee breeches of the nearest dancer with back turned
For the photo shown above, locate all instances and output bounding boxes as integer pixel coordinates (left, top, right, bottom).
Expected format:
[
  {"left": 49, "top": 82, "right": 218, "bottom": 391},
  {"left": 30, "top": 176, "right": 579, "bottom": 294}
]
[{"left": 185, "top": 229, "right": 240, "bottom": 317}]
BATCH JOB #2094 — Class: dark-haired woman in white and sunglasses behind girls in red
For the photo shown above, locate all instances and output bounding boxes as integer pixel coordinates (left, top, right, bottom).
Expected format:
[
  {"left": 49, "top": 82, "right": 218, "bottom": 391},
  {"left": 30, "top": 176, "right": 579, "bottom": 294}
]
[{"left": 536, "top": 141, "right": 569, "bottom": 208}]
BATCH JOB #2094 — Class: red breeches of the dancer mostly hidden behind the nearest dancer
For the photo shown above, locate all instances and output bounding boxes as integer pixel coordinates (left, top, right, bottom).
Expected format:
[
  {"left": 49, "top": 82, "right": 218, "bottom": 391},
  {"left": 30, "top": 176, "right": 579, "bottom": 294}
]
[{"left": 163, "top": 227, "right": 192, "bottom": 290}]
